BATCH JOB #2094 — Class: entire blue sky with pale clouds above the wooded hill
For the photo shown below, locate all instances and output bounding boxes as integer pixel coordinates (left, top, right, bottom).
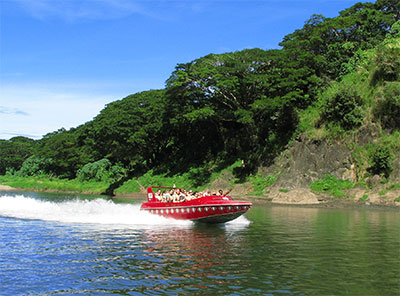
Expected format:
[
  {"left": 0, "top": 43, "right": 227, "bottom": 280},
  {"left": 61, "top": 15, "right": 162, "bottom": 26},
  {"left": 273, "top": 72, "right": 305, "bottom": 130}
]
[{"left": 0, "top": 0, "right": 365, "bottom": 139}]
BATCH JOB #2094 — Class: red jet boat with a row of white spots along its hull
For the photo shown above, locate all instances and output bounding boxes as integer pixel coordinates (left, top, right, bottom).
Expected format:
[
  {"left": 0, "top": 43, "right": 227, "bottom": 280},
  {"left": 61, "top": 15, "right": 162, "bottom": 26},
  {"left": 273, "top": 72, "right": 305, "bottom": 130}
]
[{"left": 140, "top": 186, "right": 252, "bottom": 223}]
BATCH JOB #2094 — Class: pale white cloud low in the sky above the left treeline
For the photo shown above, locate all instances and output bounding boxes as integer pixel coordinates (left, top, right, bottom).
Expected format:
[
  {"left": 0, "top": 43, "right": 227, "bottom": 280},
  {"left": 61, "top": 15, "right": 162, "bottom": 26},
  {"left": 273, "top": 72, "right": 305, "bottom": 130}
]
[{"left": 0, "top": 85, "right": 115, "bottom": 139}]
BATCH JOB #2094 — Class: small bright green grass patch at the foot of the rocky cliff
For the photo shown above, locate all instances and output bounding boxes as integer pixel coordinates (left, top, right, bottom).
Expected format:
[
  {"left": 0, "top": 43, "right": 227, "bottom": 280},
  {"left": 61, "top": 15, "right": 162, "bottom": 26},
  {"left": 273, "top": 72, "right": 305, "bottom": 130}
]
[{"left": 310, "top": 175, "right": 354, "bottom": 198}]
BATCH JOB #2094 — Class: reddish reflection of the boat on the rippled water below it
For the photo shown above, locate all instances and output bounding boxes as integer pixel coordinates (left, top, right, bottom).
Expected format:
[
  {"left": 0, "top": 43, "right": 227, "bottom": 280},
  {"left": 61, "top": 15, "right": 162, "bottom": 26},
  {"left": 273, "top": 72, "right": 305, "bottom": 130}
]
[{"left": 144, "top": 224, "right": 250, "bottom": 288}]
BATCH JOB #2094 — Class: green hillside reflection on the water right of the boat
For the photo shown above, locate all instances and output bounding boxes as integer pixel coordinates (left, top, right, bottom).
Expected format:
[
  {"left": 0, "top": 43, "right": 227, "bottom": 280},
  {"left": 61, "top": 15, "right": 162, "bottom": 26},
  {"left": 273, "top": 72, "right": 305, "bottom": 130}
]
[{"left": 245, "top": 207, "right": 400, "bottom": 295}]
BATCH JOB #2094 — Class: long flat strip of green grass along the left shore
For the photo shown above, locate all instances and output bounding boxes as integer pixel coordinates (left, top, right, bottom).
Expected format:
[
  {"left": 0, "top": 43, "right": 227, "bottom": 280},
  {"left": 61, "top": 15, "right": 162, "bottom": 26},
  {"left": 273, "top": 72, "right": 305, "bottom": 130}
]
[{"left": 0, "top": 175, "right": 110, "bottom": 194}]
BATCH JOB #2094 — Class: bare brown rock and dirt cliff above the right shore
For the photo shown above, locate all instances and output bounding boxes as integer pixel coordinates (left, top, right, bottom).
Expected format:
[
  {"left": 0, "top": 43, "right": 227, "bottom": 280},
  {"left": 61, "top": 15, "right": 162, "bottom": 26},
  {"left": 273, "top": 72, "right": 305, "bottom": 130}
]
[{"left": 216, "top": 133, "right": 400, "bottom": 206}]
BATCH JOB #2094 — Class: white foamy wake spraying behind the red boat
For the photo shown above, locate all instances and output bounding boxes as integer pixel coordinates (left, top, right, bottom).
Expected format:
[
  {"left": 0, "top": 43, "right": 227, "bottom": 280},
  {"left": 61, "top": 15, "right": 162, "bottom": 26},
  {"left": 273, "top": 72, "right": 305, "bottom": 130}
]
[{"left": 0, "top": 195, "right": 250, "bottom": 227}]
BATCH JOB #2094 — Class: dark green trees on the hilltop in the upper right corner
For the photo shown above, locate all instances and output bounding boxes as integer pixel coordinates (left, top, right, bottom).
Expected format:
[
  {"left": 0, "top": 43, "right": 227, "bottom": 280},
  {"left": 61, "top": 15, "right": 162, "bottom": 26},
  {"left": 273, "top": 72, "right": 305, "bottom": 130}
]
[{"left": 280, "top": 0, "right": 399, "bottom": 80}]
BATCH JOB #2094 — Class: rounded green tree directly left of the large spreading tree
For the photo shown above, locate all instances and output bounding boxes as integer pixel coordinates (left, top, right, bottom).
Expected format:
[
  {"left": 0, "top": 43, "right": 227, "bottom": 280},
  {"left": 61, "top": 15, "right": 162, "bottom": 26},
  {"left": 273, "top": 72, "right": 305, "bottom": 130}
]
[{"left": 78, "top": 90, "right": 166, "bottom": 170}]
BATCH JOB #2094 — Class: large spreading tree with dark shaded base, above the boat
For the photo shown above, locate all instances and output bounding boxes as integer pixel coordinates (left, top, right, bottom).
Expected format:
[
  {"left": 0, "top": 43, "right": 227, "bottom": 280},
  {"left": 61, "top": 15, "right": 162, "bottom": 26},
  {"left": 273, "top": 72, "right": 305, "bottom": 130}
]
[{"left": 166, "top": 49, "right": 300, "bottom": 173}]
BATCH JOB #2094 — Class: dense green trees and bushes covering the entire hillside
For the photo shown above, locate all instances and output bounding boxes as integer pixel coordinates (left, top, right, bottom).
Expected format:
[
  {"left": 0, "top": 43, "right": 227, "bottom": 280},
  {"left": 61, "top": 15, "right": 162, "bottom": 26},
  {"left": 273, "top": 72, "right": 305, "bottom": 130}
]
[{"left": 0, "top": 0, "right": 400, "bottom": 192}]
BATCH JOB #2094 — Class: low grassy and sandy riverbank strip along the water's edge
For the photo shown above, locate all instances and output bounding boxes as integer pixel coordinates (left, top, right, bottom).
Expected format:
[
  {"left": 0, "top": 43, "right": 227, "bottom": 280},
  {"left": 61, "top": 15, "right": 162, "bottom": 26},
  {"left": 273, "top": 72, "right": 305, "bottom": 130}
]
[{"left": 0, "top": 178, "right": 400, "bottom": 208}]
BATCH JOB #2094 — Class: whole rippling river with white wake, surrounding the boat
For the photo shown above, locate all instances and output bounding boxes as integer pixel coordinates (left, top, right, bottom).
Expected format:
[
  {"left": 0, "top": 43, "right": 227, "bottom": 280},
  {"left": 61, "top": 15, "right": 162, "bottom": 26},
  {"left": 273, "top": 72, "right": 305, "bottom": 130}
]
[{"left": 0, "top": 192, "right": 400, "bottom": 295}]
